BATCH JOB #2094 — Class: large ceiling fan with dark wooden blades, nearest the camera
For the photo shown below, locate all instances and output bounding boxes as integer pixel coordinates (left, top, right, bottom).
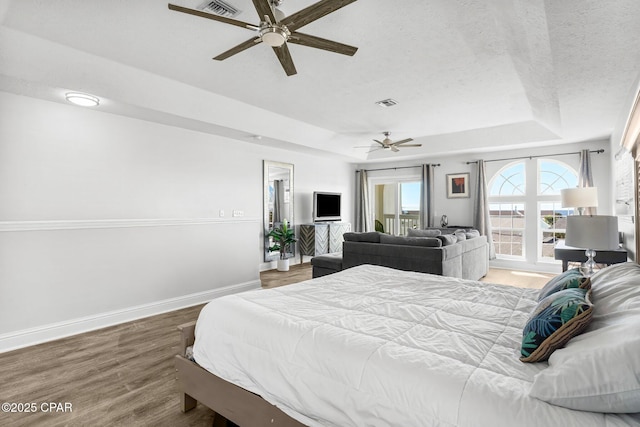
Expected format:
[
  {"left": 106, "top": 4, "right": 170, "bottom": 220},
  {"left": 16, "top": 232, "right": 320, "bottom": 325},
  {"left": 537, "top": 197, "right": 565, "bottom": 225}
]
[{"left": 169, "top": 0, "right": 358, "bottom": 76}]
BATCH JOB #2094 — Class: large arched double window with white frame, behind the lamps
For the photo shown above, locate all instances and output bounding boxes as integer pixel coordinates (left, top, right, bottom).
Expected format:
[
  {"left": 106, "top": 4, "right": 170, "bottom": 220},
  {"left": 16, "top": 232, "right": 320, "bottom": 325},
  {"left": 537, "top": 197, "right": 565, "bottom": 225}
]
[{"left": 489, "top": 159, "right": 578, "bottom": 262}]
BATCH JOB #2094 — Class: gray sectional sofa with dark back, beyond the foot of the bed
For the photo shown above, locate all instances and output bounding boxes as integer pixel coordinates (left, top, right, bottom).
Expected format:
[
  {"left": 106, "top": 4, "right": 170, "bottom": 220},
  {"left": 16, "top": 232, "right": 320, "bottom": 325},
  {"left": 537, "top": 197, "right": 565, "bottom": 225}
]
[{"left": 311, "top": 228, "right": 489, "bottom": 280}]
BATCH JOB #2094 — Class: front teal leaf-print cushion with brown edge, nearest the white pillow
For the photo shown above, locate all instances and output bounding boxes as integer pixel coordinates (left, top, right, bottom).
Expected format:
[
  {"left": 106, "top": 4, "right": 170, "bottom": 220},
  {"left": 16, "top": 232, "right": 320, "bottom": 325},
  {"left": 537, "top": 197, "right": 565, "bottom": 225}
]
[{"left": 520, "top": 288, "right": 593, "bottom": 362}]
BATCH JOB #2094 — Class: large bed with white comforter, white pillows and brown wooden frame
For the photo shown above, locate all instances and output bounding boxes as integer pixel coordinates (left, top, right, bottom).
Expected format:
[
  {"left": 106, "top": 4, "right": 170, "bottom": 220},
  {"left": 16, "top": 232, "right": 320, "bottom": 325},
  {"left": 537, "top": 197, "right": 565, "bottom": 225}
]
[{"left": 176, "top": 263, "right": 640, "bottom": 427}]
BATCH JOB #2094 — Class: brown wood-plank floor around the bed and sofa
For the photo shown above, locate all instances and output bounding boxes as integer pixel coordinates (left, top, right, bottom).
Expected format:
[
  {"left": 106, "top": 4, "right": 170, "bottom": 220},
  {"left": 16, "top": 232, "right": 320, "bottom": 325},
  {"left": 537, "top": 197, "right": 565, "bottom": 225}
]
[{"left": 0, "top": 263, "right": 553, "bottom": 427}]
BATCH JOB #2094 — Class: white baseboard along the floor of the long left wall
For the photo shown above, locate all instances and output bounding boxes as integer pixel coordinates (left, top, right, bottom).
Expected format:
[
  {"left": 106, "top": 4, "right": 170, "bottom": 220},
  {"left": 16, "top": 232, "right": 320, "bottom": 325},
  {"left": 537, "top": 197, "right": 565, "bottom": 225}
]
[{"left": 0, "top": 280, "right": 260, "bottom": 353}]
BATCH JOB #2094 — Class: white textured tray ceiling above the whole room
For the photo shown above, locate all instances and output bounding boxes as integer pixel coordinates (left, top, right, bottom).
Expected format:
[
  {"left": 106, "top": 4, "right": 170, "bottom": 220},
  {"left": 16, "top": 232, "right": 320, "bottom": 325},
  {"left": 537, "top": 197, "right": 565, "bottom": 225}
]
[{"left": 0, "top": 0, "right": 640, "bottom": 162}]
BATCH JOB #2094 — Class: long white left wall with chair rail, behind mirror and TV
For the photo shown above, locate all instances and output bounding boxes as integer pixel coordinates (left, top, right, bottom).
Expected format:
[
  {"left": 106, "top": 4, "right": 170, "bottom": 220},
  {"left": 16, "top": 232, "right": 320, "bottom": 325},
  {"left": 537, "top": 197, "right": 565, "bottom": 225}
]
[{"left": 0, "top": 92, "right": 354, "bottom": 351}]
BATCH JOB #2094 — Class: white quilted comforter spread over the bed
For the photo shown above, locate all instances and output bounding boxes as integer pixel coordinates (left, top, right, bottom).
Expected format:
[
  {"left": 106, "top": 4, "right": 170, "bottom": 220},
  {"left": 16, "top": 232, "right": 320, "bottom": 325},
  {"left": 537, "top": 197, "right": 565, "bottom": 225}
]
[{"left": 194, "top": 266, "right": 637, "bottom": 427}]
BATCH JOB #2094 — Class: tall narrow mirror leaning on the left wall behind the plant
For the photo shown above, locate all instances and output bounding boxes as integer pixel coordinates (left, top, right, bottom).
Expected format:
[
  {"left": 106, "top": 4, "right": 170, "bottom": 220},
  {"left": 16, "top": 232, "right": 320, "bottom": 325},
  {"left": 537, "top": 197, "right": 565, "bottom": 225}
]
[{"left": 262, "top": 160, "right": 295, "bottom": 261}]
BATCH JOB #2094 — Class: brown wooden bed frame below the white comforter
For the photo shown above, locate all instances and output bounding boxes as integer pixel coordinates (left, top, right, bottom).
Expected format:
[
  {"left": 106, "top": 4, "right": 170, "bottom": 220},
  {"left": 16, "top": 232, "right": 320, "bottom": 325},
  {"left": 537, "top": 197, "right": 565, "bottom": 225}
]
[{"left": 175, "top": 322, "right": 304, "bottom": 427}]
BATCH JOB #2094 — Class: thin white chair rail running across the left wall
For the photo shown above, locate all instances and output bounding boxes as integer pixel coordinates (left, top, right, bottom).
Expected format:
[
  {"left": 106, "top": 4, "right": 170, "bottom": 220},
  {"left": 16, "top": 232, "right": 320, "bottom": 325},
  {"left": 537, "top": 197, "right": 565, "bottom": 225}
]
[{"left": 0, "top": 217, "right": 262, "bottom": 232}]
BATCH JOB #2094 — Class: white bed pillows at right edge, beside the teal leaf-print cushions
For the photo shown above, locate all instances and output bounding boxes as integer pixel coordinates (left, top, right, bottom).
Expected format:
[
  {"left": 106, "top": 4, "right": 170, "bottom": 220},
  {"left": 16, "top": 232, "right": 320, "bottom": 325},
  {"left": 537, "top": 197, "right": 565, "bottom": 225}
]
[{"left": 530, "top": 263, "right": 640, "bottom": 413}]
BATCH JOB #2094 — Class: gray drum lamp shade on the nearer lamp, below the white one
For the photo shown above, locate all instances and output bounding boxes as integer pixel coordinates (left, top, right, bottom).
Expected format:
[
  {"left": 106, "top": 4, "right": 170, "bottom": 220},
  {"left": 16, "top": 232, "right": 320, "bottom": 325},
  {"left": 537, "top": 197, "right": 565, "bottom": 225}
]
[{"left": 565, "top": 215, "right": 618, "bottom": 250}]
